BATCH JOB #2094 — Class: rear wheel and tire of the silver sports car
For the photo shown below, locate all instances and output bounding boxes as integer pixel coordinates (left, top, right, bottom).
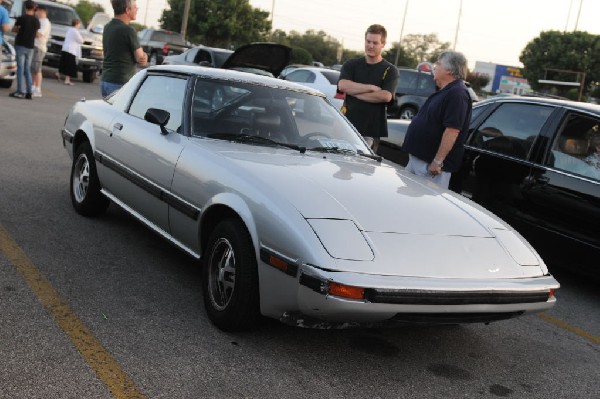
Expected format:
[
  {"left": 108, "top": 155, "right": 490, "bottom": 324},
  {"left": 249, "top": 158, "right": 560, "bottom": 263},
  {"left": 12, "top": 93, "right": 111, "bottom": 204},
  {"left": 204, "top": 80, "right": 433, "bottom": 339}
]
[{"left": 70, "top": 141, "right": 109, "bottom": 216}]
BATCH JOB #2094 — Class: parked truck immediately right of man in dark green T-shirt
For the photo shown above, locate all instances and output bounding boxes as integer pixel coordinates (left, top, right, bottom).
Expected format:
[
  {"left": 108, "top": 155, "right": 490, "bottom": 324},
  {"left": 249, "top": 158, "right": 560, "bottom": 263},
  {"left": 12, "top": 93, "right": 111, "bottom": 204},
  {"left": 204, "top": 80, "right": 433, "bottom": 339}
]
[{"left": 138, "top": 29, "right": 191, "bottom": 65}]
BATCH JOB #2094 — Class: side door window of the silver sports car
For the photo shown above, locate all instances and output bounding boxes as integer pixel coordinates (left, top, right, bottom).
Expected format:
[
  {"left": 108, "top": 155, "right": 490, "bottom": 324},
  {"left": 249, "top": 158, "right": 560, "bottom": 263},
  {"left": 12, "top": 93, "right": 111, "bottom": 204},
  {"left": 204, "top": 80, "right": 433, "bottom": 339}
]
[{"left": 129, "top": 75, "right": 187, "bottom": 132}]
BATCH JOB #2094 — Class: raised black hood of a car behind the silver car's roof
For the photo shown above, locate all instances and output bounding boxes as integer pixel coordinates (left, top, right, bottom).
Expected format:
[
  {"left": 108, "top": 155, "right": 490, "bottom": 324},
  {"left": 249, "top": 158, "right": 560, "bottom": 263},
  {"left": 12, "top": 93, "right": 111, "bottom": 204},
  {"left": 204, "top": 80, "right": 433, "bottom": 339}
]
[{"left": 221, "top": 43, "right": 292, "bottom": 76}]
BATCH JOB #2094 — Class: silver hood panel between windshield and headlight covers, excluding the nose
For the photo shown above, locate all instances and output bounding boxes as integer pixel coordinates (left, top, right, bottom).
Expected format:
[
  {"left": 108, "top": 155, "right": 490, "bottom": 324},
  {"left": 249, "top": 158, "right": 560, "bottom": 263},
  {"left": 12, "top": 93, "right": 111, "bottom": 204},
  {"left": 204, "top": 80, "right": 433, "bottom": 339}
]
[{"left": 213, "top": 145, "right": 500, "bottom": 237}]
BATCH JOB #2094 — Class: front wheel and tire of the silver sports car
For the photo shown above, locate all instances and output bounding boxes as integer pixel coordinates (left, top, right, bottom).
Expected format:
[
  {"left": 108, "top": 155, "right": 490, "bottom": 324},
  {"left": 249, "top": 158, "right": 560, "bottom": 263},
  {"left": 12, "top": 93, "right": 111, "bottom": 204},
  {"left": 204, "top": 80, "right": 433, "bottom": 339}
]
[{"left": 202, "top": 218, "right": 260, "bottom": 331}]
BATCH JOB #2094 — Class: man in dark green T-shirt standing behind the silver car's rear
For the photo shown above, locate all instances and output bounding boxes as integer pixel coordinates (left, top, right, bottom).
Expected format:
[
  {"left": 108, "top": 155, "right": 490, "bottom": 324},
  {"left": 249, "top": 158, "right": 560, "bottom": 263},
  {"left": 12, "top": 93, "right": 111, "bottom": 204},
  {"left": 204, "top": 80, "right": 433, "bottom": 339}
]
[{"left": 100, "top": 0, "right": 148, "bottom": 97}]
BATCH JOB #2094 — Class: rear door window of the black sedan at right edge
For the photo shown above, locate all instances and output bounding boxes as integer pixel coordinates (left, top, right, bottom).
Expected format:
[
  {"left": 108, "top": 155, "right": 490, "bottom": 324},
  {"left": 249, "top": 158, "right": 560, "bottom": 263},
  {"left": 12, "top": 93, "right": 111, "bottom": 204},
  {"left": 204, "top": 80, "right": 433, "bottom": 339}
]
[{"left": 546, "top": 114, "right": 600, "bottom": 180}]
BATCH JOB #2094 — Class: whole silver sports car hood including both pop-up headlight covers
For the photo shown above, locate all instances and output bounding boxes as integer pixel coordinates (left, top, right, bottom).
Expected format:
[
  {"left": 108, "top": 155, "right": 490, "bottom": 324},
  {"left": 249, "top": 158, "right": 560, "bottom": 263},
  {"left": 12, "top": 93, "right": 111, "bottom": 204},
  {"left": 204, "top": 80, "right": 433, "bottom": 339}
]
[{"left": 191, "top": 141, "right": 545, "bottom": 278}]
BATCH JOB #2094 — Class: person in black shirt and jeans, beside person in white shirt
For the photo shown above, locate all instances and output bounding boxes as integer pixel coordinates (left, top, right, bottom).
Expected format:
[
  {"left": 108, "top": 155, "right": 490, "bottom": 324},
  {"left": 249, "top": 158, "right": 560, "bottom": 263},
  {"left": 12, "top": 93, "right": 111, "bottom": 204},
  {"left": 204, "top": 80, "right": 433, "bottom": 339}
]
[{"left": 9, "top": 0, "right": 40, "bottom": 100}]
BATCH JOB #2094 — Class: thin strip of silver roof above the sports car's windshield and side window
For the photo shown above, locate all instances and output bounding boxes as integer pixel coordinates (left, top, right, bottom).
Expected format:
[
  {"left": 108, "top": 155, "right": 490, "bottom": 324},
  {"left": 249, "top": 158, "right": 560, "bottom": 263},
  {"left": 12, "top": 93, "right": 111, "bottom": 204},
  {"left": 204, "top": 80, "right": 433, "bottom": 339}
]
[{"left": 146, "top": 65, "right": 325, "bottom": 97}]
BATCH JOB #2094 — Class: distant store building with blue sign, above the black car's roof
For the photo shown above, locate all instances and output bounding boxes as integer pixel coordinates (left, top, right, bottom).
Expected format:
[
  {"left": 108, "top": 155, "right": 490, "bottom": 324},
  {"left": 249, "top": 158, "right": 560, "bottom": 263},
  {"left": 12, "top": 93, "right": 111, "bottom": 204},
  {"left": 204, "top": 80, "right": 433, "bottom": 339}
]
[{"left": 473, "top": 61, "right": 533, "bottom": 95}]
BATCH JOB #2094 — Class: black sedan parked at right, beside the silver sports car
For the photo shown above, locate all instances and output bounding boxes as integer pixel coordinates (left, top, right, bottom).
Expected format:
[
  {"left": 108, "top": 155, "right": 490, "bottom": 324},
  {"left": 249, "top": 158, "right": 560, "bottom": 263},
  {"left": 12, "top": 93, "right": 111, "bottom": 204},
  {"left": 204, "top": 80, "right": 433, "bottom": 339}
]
[{"left": 382, "top": 96, "right": 600, "bottom": 276}]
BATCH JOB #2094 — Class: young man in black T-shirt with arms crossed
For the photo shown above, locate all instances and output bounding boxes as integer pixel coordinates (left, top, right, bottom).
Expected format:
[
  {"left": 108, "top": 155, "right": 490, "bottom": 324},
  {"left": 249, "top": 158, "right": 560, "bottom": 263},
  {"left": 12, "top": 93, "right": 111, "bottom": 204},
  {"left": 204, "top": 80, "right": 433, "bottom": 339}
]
[{"left": 338, "top": 25, "right": 398, "bottom": 151}]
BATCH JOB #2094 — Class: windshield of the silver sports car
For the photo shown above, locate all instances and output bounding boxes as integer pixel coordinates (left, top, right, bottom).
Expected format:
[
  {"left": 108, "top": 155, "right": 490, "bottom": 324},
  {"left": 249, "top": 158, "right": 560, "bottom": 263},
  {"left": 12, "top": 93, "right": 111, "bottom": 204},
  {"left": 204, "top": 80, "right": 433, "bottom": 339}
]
[{"left": 192, "top": 80, "right": 371, "bottom": 154}]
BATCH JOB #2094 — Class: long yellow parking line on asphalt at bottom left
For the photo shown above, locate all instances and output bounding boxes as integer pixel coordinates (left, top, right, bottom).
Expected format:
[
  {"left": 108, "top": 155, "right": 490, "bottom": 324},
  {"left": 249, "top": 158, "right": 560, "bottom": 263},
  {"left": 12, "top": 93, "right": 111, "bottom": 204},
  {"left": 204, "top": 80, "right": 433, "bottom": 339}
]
[{"left": 0, "top": 225, "right": 145, "bottom": 399}]
